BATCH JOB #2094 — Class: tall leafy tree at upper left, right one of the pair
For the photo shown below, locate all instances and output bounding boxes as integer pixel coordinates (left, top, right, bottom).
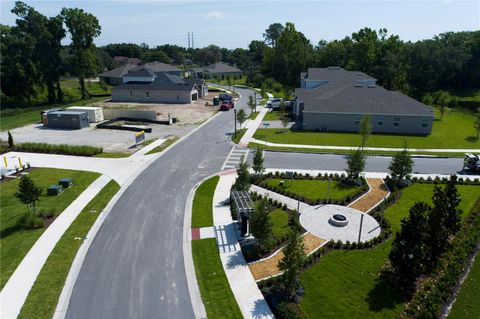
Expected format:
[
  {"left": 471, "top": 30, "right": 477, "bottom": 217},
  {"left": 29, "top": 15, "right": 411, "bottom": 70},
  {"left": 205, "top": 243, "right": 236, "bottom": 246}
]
[{"left": 61, "top": 8, "right": 101, "bottom": 99}]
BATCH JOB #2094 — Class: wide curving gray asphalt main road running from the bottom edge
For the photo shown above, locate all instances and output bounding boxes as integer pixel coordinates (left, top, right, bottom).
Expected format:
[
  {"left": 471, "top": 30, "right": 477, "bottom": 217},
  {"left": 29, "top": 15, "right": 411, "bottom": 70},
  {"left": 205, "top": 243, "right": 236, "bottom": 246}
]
[{"left": 66, "top": 89, "right": 250, "bottom": 319}]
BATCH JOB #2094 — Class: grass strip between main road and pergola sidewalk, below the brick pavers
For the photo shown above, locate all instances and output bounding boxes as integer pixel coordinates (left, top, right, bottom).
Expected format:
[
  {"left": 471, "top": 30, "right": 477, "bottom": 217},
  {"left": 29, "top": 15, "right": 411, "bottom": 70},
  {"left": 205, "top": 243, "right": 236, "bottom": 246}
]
[{"left": 192, "top": 238, "right": 243, "bottom": 319}]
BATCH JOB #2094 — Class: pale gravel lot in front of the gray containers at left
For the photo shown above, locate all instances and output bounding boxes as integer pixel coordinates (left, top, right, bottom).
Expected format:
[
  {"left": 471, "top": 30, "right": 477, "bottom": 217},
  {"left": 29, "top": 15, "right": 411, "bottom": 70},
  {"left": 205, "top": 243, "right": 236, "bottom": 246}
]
[{"left": 0, "top": 124, "right": 196, "bottom": 153}]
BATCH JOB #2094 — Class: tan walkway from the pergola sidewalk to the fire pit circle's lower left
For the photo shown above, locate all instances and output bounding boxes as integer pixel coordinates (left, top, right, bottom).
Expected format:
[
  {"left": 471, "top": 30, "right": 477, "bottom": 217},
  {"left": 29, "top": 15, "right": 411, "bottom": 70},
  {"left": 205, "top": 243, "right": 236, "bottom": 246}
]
[{"left": 248, "top": 232, "right": 326, "bottom": 281}]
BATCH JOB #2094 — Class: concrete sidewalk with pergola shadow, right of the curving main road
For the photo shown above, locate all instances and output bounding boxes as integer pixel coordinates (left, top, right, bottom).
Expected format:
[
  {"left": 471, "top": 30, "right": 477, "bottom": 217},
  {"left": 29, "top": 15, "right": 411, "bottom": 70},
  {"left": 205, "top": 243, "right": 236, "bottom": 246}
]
[{"left": 213, "top": 171, "right": 274, "bottom": 319}]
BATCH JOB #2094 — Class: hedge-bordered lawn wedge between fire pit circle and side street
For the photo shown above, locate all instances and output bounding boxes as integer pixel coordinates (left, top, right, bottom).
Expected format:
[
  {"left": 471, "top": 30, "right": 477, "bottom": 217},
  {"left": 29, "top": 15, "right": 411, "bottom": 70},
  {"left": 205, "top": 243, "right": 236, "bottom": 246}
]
[{"left": 265, "top": 178, "right": 360, "bottom": 201}]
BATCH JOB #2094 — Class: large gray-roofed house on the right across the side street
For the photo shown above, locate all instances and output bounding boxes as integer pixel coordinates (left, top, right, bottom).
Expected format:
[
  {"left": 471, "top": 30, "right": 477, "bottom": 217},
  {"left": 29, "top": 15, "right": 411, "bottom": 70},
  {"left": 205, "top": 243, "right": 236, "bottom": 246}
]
[{"left": 294, "top": 67, "right": 434, "bottom": 135}]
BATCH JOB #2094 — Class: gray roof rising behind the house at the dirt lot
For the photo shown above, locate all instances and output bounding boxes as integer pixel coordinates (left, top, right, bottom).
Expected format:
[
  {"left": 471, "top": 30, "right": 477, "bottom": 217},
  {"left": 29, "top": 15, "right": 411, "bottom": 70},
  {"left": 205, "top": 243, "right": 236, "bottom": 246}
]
[{"left": 99, "top": 62, "right": 182, "bottom": 85}]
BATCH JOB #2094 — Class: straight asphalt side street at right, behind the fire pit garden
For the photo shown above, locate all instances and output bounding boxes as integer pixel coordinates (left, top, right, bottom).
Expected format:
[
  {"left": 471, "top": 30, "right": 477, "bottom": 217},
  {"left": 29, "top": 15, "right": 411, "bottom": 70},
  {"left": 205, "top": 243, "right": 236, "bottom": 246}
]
[{"left": 253, "top": 151, "right": 470, "bottom": 174}]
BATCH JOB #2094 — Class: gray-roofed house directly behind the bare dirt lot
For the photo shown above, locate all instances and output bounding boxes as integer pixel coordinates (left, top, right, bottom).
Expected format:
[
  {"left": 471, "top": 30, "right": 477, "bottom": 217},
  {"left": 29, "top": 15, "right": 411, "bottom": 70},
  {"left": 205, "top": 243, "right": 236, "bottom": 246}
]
[{"left": 112, "top": 68, "right": 201, "bottom": 104}]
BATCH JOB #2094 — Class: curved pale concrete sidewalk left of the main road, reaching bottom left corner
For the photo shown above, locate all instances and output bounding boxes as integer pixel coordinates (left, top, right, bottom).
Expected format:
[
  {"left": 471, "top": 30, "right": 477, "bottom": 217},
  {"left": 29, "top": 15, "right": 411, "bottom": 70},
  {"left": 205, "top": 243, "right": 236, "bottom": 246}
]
[{"left": 0, "top": 175, "right": 111, "bottom": 319}]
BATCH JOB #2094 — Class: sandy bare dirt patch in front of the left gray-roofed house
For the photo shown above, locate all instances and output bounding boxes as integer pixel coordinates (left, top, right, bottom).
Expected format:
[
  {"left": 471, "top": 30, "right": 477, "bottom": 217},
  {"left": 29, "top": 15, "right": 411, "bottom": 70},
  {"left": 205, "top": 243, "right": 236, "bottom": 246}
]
[{"left": 95, "top": 94, "right": 219, "bottom": 125}]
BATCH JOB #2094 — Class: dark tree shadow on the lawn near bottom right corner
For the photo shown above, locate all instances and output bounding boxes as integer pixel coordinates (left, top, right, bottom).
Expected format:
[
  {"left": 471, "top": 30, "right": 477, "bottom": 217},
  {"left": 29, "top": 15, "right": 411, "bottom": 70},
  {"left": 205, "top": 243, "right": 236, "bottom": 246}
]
[{"left": 365, "top": 280, "right": 404, "bottom": 312}]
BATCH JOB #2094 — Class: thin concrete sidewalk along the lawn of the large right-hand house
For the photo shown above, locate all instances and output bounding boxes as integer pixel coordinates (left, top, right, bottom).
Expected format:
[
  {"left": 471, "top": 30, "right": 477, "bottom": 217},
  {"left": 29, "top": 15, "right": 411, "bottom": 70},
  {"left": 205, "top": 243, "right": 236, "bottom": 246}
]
[{"left": 249, "top": 138, "right": 480, "bottom": 153}]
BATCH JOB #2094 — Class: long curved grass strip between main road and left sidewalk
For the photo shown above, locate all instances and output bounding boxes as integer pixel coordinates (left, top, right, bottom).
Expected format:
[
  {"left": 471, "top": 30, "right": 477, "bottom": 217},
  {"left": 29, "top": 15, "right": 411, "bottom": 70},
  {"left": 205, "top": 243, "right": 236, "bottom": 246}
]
[{"left": 19, "top": 180, "right": 120, "bottom": 319}]
